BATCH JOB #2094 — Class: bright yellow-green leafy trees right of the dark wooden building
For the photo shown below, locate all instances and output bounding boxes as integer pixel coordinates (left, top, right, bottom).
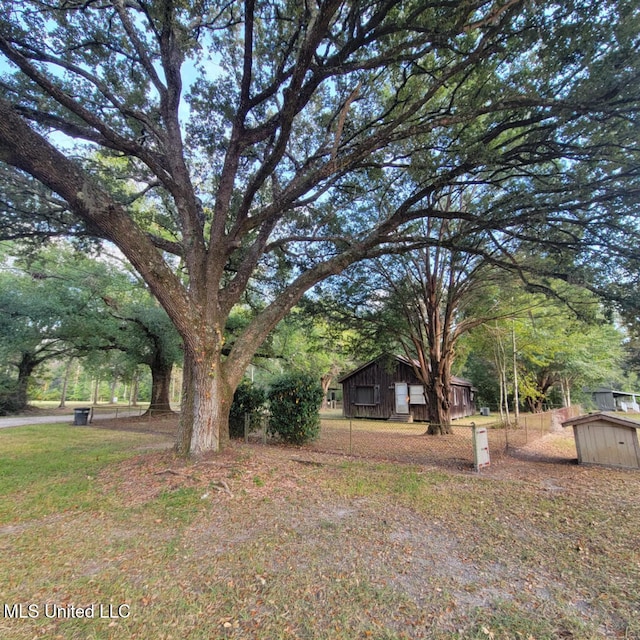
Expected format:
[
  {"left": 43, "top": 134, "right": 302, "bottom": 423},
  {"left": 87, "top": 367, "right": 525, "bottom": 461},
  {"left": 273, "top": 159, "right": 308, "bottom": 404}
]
[{"left": 464, "top": 280, "right": 627, "bottom": 410}]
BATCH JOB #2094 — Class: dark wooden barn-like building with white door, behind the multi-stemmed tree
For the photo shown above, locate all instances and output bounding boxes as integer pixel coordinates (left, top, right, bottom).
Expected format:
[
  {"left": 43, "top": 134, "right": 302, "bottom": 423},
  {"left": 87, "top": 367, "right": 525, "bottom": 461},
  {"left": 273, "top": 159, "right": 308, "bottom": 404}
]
[{"left": 338, "top": 355, "right": 475, "bottom": 421}]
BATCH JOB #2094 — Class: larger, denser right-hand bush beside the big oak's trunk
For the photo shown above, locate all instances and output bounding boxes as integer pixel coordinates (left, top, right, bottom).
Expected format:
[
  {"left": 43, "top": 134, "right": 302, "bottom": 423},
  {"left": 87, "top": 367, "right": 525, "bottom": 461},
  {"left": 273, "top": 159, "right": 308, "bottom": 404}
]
[{"left": 268, "top": 374, "right": 322, "bottom": 444}]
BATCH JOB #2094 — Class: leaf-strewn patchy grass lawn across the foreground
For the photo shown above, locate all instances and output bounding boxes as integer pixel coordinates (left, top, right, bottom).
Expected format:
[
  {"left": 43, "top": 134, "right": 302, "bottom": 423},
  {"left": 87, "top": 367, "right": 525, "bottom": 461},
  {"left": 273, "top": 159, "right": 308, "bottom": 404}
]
[{"left": 0, "top": 425, "right": 640, "bottom": 640}]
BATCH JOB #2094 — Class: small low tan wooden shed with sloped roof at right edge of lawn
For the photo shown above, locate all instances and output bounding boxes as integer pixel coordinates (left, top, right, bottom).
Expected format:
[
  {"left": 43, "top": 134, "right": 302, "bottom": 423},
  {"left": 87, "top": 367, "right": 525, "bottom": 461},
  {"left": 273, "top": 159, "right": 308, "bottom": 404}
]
[{"left": 562, "top": 412, "right": 640, "bottom": 469}]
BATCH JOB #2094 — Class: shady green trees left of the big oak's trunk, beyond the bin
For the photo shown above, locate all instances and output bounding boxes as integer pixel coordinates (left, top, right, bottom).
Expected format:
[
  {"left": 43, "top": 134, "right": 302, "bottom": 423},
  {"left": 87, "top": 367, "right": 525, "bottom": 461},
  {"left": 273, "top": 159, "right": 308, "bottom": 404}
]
[{"left": 0, "top": 242, "right": 182, "bottom": 410}]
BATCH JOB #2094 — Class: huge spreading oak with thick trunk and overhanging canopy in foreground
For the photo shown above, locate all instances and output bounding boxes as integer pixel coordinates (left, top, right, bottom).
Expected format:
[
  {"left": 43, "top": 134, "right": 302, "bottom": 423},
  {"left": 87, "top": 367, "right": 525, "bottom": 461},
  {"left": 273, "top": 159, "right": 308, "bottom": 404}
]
[{"left": 0, "top": 0, "right": 639, "bottom": 454}]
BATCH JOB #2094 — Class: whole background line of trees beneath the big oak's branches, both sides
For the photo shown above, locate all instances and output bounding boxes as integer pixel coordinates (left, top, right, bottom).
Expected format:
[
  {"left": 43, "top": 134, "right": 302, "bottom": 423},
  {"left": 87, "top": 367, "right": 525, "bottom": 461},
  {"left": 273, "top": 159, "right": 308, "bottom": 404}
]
[{"left": 0, "top": 240, "right": 636, "bottom": 422}]
